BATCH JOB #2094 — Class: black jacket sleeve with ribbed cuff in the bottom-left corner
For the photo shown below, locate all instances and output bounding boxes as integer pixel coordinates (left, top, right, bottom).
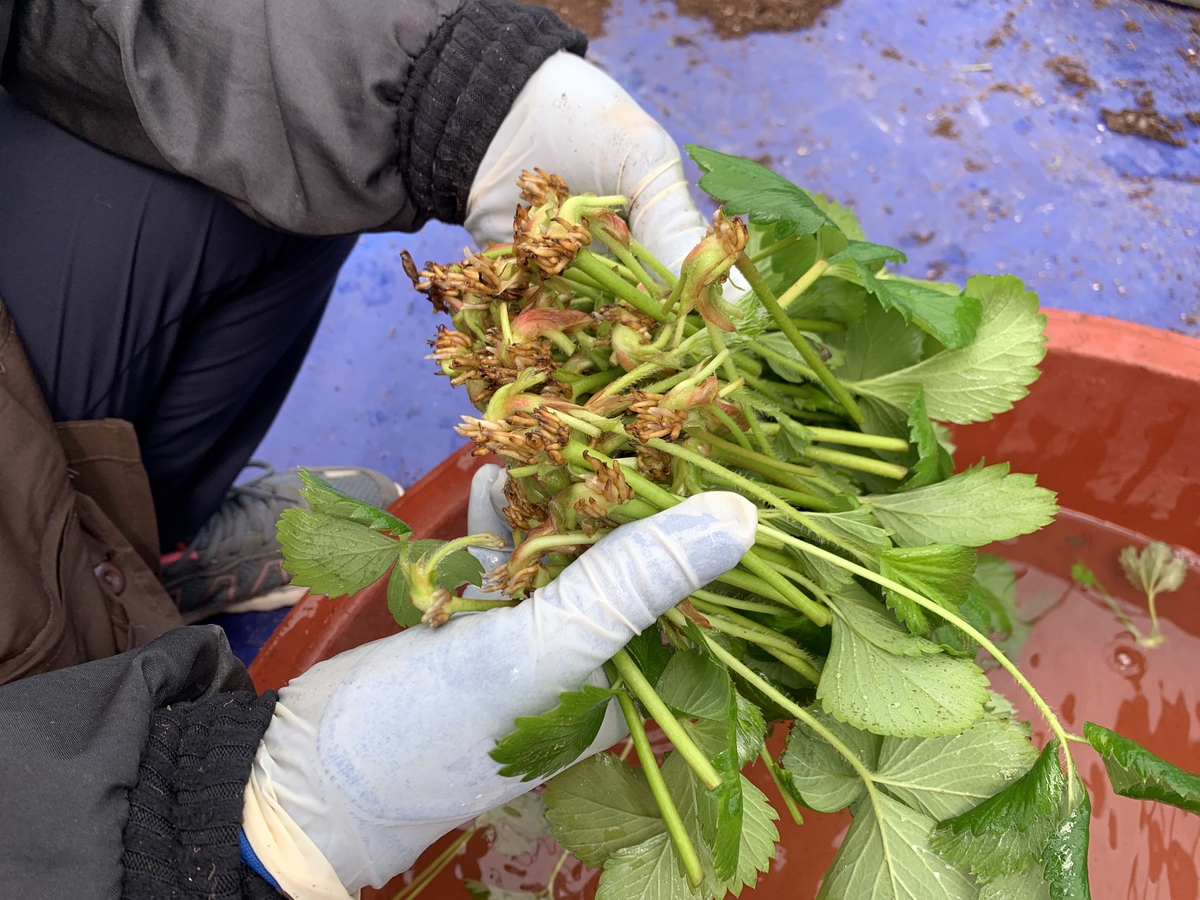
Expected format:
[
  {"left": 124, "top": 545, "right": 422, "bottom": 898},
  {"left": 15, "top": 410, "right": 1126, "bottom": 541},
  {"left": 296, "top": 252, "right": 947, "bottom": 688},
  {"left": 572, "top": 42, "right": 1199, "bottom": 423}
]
[{"left": 0, "top": 625, "right": 277, "bottom": 900}]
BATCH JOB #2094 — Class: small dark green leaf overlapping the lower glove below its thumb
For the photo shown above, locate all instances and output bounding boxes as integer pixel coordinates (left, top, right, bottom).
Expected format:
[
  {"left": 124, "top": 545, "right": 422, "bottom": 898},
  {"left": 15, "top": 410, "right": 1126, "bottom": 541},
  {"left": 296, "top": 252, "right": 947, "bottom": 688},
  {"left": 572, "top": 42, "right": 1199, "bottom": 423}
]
[{"left": 491, "top": 684, "right": 616, "bottom": 781}]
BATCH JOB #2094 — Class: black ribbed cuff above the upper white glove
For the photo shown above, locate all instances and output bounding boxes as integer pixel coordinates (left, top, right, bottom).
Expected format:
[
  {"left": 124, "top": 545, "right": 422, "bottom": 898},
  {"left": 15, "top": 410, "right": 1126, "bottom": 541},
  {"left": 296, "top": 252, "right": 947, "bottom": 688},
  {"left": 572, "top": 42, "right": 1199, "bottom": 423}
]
[{"left": 398, "top": 0, "right": 588, "bottom": 224}]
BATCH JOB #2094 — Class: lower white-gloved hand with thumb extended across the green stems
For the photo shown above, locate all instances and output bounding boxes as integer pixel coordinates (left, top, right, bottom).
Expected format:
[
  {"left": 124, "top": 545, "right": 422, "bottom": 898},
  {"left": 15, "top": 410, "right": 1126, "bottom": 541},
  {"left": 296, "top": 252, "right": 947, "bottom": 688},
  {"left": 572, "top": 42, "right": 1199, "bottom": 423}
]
[{"left": 244, "top": 475, "right": 756, "bottom": 900}]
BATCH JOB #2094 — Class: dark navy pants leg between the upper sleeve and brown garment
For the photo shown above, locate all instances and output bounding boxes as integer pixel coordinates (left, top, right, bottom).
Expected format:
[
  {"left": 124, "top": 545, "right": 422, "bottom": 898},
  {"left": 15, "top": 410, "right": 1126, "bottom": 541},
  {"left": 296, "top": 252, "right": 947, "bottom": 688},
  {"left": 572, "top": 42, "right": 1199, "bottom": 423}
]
[{"left": 0, "top": 91, "right": 355, "bottom": 551}]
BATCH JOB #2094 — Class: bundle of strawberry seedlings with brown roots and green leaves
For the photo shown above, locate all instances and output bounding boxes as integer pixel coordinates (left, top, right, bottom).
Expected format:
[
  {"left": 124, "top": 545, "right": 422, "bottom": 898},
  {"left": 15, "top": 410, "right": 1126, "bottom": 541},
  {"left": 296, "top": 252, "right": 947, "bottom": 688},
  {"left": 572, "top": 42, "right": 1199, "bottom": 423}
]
[{"left": 280, "top": 148, "right": 1200, "bottom": 900}]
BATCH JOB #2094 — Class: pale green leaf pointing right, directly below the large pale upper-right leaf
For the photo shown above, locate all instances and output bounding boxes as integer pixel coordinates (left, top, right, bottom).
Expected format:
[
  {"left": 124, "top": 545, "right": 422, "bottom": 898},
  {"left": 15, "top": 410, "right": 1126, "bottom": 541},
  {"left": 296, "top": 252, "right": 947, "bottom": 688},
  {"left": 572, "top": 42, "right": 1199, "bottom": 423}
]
[{"left": 862, "top": 463, "right": 1058, "bottom": 547}]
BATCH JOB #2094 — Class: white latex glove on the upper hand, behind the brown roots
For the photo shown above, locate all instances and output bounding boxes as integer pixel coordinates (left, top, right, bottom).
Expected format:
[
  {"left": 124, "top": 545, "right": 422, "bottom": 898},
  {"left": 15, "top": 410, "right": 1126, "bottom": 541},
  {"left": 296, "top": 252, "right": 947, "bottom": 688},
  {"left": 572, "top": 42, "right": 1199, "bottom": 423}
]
[{"left": 466, "top": 52, "right": 706, "bottom": 272}]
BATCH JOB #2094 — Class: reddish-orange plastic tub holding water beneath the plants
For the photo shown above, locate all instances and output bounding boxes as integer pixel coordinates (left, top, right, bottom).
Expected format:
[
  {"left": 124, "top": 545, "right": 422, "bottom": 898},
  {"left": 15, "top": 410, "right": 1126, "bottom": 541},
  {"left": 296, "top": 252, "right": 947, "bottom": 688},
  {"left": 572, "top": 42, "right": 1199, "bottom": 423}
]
[{"left": 250, "top": 310, "right": 1200, "bottom": 900}]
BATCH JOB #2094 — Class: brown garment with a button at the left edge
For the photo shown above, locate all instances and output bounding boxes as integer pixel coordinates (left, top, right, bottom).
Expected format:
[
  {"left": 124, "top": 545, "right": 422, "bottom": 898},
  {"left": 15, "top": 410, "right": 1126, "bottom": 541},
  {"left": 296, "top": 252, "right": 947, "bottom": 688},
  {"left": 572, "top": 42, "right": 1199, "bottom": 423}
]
[{"left": 0, "top": 301, "right": 182, "bottom": 684}]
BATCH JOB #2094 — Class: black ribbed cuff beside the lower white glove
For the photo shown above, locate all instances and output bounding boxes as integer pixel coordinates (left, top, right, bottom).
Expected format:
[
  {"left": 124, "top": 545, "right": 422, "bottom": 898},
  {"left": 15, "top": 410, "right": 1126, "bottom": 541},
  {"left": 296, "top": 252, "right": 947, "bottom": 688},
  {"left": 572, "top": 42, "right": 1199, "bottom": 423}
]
[{"left": 121, "top": 691, "right": 278, "bottom": 900}]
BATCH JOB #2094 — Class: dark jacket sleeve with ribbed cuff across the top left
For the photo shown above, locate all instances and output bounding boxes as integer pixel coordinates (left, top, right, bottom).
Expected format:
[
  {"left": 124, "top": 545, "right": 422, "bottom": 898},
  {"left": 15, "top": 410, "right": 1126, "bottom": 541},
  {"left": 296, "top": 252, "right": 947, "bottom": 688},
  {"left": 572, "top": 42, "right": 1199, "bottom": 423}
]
[{"left": 0, "top": 0, "right": 587, "bottom": 235}]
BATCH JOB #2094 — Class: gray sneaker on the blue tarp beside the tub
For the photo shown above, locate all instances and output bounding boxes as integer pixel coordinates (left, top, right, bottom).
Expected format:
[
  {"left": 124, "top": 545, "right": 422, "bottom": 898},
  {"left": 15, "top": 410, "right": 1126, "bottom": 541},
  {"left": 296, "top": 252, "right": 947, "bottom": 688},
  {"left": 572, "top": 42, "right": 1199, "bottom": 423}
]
[{"left": 162, "top": 460, "right": 404, "bottom": 624}]
